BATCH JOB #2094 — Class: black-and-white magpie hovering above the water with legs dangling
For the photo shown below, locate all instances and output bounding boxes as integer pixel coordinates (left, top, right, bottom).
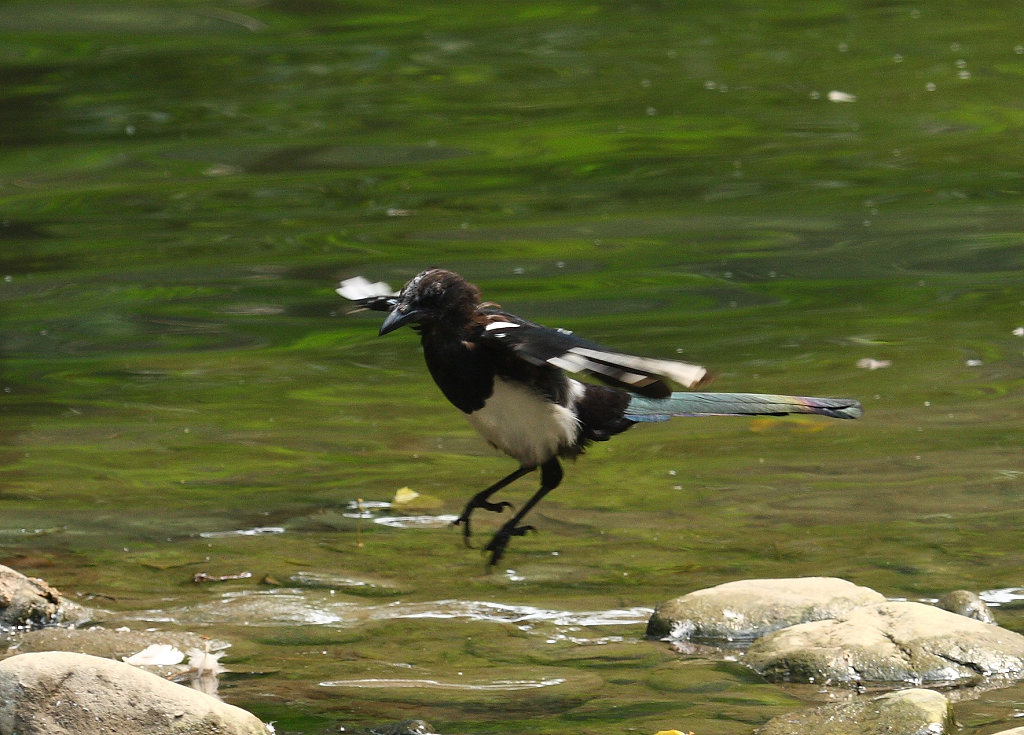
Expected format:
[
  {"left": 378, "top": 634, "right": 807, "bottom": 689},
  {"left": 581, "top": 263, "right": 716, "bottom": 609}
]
[{"left": 337, "top": 268, "right": 862, "bottom": 566}]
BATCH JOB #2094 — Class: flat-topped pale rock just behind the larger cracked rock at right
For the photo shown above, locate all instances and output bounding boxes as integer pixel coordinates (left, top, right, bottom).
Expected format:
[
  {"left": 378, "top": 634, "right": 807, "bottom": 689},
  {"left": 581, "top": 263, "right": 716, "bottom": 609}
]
[{"left": 647, "top": 576, "right": 885, "bottom": 641}]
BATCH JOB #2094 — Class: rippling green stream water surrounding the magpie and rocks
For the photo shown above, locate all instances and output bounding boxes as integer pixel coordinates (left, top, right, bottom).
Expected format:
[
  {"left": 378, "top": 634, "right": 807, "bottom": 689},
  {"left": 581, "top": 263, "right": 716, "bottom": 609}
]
[{"left": 0, "top": 0, "right": 1024, "bottom": 735}]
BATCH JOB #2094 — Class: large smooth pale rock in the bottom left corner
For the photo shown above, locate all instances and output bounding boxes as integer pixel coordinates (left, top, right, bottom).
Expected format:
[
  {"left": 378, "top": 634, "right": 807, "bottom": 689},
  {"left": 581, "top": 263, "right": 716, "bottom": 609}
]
[{"left": 0, "top": 652, "right": 268, "bottom": 735}]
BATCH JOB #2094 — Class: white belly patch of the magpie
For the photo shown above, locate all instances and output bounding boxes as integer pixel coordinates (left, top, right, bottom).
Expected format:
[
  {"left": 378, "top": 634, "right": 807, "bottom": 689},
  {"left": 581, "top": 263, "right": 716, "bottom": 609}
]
[{"left": 467, "top": 378, "right": 578, "bottom": 467}]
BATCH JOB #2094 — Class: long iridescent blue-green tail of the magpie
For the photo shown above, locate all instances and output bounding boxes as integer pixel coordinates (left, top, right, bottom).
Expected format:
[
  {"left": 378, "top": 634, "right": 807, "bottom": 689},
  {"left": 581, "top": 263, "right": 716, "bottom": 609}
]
[{"left": 626, "top": 393, "right": 864, "bottom": 422}]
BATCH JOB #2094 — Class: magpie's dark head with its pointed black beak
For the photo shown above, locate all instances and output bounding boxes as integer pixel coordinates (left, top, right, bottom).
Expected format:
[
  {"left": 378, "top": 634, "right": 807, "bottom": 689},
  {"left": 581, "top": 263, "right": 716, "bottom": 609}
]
[{"left": 380, "top": 268, "right": 480, "bottom": 335}]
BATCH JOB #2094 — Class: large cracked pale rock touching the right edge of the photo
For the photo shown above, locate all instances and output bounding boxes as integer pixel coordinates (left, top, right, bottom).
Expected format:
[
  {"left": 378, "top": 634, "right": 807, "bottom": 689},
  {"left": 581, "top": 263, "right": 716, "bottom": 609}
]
[{"left": 744, "top": 602, "right": 1024, "bottom": 685}]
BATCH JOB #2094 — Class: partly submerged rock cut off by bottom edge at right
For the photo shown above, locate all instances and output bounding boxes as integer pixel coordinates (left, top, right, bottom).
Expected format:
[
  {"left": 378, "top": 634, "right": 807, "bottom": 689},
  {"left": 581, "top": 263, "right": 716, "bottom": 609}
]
[{"left": 758, "top": 689, "right": 955, "bottom": 735}]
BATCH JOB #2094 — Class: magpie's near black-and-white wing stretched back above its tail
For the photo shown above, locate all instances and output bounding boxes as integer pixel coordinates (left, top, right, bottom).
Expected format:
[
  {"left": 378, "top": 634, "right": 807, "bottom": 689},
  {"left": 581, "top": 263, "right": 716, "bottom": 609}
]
[{"left": 479, "top": 309, "right": 708, "bottom": 398}]
